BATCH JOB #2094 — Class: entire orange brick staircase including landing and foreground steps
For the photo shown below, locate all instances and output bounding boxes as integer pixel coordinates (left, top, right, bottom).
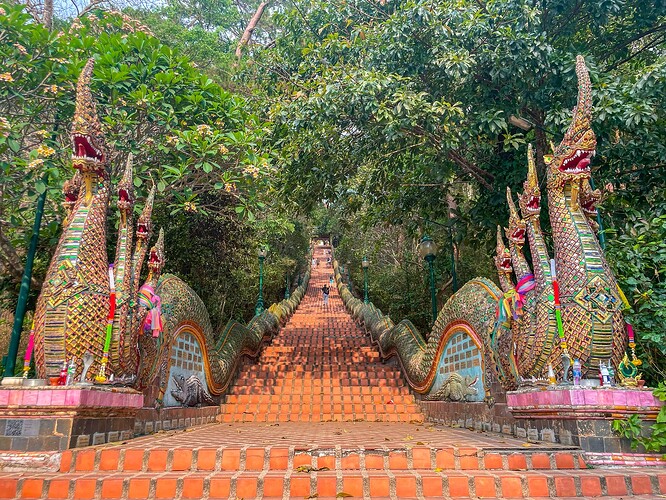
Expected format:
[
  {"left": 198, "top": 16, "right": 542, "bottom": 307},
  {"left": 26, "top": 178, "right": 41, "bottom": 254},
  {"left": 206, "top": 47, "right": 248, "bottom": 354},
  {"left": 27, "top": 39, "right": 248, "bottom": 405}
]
[{"left": 0, "top": 247, "right": 666, "bottom": 499}]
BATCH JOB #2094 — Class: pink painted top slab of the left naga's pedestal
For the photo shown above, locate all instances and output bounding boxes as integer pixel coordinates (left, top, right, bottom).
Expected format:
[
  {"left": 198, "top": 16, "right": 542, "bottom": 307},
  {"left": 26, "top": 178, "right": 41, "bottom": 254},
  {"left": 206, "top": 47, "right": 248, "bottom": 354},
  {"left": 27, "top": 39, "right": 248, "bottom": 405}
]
[{"left": 0, "top": 386, "right": 143, "bottom": 411}]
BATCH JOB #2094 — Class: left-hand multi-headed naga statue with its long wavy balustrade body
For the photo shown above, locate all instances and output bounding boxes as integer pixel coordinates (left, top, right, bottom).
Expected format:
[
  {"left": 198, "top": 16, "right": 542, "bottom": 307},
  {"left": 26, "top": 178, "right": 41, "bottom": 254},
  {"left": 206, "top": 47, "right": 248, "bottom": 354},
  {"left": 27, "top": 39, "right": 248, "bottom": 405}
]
[{"left": 34, "top": 59, "right": 309, "bottom": 406}]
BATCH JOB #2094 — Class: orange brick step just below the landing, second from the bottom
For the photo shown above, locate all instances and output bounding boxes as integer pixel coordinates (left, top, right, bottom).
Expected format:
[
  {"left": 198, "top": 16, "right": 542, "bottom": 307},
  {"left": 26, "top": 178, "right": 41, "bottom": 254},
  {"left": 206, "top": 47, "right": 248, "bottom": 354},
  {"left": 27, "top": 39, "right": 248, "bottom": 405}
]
[{"left": 60, "top": 445, "right": 587, "bottom": 473}]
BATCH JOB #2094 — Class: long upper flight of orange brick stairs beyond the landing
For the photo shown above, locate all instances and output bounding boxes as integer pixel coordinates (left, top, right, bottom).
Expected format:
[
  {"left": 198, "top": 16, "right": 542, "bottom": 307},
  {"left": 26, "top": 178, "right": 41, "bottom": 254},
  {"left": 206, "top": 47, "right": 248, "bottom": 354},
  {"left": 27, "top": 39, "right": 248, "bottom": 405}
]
[{"left": 219, "top": 247, "right": 424, "bottom": 422}]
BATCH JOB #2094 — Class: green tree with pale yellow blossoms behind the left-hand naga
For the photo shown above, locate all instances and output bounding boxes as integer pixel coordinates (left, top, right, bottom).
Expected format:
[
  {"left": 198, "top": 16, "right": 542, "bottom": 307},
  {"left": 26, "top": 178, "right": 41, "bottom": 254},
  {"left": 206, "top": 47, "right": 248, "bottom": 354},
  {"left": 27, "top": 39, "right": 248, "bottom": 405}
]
[{"left": 0, "top": 4, "right": 301, "bottom": 324}]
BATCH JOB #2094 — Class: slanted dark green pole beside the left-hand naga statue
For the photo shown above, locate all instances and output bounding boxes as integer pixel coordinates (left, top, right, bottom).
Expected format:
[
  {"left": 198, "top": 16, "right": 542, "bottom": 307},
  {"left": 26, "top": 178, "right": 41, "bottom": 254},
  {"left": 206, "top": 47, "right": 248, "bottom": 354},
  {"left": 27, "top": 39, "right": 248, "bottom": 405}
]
[{"left": 4, "top": 174, "right": 48, "bottom": 377}]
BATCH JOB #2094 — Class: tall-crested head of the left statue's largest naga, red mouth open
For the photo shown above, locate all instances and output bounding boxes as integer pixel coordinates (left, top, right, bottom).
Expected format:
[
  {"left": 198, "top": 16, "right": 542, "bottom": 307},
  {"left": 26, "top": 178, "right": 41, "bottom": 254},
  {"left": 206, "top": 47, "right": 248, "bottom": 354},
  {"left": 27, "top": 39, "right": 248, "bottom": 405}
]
[{"left": 72, "top": 58, "right": 106, "bottom": 175}]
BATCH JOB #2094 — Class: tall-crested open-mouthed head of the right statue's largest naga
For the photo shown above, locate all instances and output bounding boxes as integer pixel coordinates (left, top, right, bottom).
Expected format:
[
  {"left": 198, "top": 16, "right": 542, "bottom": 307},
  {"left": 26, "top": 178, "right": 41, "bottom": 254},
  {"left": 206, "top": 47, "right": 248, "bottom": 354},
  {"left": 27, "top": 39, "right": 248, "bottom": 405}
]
[{"left": 548, "top": 56, "right": 597, "bottom": 188}]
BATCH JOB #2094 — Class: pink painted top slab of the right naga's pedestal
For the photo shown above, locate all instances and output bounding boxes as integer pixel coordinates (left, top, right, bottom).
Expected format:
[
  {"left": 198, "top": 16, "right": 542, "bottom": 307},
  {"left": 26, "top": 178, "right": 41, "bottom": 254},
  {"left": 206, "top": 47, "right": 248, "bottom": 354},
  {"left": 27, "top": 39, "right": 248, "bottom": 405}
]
[{"left": 506, "top": 386, "right": 663, "bottom": 413}]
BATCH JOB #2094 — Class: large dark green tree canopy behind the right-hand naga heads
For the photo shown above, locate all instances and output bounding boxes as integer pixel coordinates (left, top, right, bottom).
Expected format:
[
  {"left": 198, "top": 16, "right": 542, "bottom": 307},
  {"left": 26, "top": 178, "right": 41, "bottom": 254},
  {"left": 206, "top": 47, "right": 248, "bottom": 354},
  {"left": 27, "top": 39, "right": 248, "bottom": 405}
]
[{"left": 235, "top": 0, "right": 666, "bottom": 376}]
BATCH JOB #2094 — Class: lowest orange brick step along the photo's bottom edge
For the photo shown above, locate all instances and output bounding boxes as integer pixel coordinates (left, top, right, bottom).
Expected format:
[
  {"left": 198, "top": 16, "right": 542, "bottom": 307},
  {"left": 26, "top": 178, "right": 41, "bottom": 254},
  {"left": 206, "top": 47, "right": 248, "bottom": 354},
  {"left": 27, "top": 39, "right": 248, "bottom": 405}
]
[{"left": 6, "top": 470, "right": 666, "bottom": 499}]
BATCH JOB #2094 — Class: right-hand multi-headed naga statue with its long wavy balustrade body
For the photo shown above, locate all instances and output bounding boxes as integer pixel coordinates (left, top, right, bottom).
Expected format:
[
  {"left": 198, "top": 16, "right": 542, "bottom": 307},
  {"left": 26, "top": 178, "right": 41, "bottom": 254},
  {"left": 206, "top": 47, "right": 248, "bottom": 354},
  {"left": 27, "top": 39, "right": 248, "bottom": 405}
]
[{"left": 336, "top": 56, "right": 627, "bottom": 402}]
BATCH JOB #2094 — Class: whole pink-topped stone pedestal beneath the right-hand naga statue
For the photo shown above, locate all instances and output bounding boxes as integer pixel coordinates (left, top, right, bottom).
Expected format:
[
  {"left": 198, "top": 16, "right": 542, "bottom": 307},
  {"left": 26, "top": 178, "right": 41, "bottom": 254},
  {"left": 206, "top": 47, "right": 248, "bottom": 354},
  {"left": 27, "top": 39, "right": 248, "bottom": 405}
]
[{"left": 419, "top": 386, "right": 666, "bottom": 466}]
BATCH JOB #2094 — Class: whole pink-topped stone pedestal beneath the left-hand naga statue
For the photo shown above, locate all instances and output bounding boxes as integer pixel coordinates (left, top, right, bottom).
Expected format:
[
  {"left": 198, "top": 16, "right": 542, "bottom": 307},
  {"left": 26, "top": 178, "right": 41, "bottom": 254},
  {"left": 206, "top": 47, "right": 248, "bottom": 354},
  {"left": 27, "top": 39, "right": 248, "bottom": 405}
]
[{"left": 0, "top": 386, "right": 143, "bottom": 451}]
